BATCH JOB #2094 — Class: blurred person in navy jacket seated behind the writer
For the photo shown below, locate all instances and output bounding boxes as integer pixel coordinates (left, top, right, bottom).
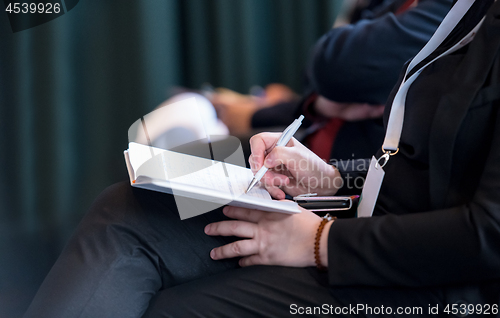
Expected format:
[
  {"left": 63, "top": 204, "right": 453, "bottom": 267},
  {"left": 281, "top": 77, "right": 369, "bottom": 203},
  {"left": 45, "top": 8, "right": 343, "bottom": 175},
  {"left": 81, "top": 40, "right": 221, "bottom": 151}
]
[{"left": 211, "top": 0, "right": 452, "bottom": 160}]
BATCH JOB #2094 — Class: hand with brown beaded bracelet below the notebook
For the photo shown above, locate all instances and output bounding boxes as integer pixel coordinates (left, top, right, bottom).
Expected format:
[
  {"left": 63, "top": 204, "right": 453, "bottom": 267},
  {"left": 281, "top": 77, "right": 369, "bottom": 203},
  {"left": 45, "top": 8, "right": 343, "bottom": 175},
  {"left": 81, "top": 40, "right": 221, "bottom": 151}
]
[{"left": 205, "top": 206, "right": 331, "bottom": 267}]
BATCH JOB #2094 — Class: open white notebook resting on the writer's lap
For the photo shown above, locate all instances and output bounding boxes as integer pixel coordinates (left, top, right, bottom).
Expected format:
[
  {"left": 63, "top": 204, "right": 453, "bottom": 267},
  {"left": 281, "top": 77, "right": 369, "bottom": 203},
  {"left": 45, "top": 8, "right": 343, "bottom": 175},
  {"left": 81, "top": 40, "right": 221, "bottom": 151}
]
[{"left": 124, "top": 142, "right": 300, "bottom": 219}]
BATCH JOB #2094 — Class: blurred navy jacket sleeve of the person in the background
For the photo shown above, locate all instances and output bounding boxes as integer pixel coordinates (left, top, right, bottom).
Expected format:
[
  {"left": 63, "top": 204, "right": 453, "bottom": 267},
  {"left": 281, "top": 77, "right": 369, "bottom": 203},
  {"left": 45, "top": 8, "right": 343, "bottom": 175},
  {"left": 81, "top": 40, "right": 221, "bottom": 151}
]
[{"left": 307, "top": 0, "right": 452, "bottom": 104}]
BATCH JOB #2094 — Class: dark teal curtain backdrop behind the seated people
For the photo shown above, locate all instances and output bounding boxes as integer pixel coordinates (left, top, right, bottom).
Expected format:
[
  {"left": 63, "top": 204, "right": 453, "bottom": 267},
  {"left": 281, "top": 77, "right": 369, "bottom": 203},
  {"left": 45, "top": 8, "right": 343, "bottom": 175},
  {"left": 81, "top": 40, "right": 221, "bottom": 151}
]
[{"left": 0, "top": 0, "right": 342, "bottom": 318}]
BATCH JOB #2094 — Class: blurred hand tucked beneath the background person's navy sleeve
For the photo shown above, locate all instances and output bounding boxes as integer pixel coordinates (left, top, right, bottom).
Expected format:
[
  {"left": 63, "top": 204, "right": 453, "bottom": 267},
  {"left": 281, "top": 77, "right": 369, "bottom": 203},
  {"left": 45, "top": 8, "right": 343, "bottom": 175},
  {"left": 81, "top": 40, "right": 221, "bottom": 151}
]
[{"left": 314, "top": 96, "right": 384, "bottom": 121}]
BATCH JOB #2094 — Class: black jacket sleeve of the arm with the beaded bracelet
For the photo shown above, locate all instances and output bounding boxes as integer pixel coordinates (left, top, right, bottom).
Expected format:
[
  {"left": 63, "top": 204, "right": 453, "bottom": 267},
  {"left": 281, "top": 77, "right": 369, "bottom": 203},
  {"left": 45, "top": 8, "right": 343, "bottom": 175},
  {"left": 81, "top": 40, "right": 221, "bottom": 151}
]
[{"left": 328, "top": 108, "right": 500, "bottom": 286}]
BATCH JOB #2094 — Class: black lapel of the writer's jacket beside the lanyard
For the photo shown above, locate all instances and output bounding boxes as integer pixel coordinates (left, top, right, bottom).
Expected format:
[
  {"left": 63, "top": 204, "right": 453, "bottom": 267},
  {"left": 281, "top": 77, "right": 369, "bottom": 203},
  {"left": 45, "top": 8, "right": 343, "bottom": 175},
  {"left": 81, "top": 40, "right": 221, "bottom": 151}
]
[{"left": 429, "top": 2, "right": 500, "bottom": 209}]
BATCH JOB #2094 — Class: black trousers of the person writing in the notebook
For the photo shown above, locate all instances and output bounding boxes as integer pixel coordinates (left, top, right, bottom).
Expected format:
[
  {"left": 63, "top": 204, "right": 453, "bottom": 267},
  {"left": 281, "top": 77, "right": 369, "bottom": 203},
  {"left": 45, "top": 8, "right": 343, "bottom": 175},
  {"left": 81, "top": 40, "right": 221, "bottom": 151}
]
[{"left": 25, "top": 182, "right": 498, "bottom": 318}]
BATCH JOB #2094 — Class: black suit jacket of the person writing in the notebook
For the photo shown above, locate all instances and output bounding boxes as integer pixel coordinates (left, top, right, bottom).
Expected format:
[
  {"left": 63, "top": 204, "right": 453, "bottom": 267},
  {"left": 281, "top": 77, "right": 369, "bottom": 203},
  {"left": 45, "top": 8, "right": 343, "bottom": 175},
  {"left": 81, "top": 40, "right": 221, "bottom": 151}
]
[{"left": 328, "top": 2, "right": 500, "bottom": 303}]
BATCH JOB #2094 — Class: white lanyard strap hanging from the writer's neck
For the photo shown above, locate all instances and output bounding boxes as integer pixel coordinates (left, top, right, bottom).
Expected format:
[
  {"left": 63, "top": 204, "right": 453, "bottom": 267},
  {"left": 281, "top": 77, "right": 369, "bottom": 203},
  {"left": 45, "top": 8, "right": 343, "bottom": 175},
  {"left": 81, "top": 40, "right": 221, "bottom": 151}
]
[{"left": 382, "top": 0, "right": 484, "bottom": 153}]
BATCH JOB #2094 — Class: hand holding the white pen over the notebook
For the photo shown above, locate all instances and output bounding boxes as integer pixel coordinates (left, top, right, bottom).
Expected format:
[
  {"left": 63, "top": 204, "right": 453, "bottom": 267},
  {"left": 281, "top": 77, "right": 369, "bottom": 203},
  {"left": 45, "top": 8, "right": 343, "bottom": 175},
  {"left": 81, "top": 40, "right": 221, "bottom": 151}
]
[{"left": 249, "top": 133, "right": 342, "bottom": 199}]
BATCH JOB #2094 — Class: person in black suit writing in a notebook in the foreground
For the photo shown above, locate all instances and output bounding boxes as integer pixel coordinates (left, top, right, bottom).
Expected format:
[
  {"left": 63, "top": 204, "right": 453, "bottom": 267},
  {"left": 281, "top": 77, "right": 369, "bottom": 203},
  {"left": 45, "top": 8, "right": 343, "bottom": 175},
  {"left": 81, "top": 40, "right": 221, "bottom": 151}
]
[{"left": 25, "top": 0, "right": 500, "bottom": 318}]
